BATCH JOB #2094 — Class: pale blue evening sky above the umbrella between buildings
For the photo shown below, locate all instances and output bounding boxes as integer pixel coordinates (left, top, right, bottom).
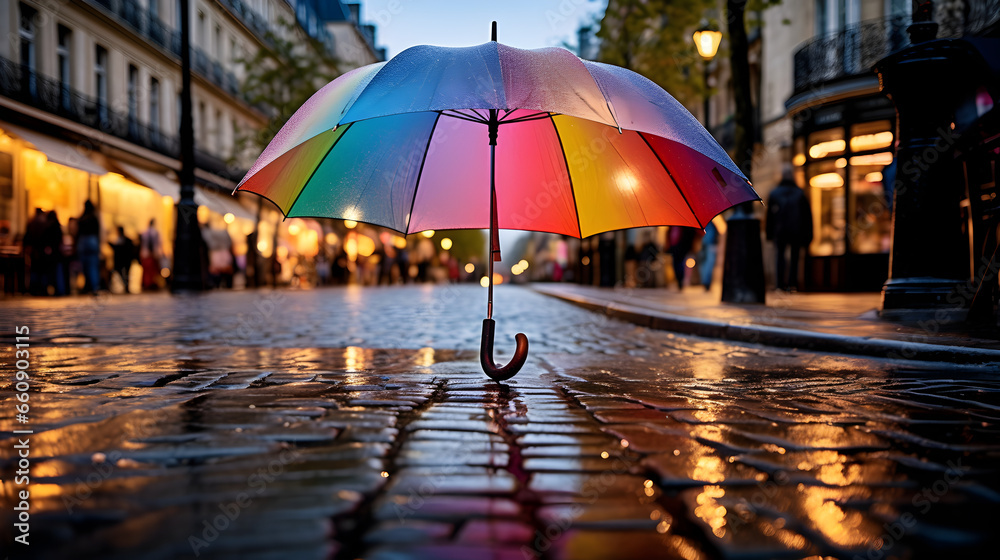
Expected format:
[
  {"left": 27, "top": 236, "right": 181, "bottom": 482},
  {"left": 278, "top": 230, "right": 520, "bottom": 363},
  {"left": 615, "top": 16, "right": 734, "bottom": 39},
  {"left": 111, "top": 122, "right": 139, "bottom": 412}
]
[{"left": 361, "top": 0, "right": 607, "bottom": 57}]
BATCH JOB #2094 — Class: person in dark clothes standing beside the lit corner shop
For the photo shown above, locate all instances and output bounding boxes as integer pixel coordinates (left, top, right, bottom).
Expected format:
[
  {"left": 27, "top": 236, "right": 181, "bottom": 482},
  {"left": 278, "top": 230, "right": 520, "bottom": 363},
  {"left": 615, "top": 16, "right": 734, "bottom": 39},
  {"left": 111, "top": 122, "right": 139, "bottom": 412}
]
[{"left": 764, "top": 164, "right": 813, "bottom": 291}]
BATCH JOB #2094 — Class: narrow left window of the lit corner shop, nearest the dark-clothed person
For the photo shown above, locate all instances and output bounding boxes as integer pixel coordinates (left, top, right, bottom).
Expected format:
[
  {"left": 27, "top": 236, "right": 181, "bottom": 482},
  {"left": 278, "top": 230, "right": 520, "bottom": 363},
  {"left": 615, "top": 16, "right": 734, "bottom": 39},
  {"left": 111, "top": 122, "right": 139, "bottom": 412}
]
[{"left": 806, "top": 161, "right": 847, "bottom": 257}]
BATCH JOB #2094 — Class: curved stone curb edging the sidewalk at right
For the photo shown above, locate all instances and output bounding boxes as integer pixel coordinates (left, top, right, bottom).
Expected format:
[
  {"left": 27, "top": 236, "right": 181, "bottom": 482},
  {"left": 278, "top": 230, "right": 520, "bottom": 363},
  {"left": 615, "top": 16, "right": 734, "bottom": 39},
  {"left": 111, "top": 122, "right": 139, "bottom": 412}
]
[{"left": 533, "top": 288, "right": 1000, "bottom": 364}]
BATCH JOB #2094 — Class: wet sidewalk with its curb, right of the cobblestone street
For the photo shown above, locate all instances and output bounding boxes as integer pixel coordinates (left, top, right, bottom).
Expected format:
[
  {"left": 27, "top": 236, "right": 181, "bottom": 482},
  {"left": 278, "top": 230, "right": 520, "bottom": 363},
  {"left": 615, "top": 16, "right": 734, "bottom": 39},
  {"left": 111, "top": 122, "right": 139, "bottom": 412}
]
[{"left": 532, "top": 284, "right": 1000, "bottom": 364}]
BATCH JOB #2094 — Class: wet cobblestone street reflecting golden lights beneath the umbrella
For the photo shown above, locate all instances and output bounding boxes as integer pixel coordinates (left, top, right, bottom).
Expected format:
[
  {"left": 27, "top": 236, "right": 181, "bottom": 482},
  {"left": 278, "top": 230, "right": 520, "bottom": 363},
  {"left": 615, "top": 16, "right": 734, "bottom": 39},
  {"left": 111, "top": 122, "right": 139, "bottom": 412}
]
[{"left": 0, "top": 286, "right": 1000, "bottom": 560}]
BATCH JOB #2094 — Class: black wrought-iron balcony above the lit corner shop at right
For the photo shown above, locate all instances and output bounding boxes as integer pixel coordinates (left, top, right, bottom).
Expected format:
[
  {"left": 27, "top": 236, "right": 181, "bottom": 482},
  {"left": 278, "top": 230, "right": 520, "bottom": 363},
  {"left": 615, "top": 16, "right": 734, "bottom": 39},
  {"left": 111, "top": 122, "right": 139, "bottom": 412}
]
[{"left": 795, "top": 16, "right": 910, "bottom": 95}]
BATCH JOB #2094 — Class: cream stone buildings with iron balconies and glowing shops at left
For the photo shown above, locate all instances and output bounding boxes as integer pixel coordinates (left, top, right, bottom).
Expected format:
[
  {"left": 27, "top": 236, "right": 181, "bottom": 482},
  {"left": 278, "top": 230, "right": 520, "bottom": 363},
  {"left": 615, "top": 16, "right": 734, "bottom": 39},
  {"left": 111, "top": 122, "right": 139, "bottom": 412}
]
[{"left": 0, "top": 0, "right": 384, "bottom": 296}]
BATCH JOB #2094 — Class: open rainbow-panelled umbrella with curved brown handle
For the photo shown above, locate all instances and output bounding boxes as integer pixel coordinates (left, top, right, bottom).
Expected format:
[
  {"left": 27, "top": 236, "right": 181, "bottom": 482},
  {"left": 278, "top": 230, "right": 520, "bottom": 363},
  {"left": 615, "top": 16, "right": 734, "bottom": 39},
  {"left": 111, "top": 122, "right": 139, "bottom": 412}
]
[{"left": 237, "top": 22, "right": 759, "bottom": 381}]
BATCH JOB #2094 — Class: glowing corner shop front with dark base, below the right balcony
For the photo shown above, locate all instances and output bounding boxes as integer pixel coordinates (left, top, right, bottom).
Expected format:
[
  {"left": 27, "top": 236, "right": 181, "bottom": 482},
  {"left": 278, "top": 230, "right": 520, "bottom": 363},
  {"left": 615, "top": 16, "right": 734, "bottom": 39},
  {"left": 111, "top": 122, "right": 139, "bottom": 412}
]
[{"left": 793, "top": 96, "right": 895, "bottom": 291}]
